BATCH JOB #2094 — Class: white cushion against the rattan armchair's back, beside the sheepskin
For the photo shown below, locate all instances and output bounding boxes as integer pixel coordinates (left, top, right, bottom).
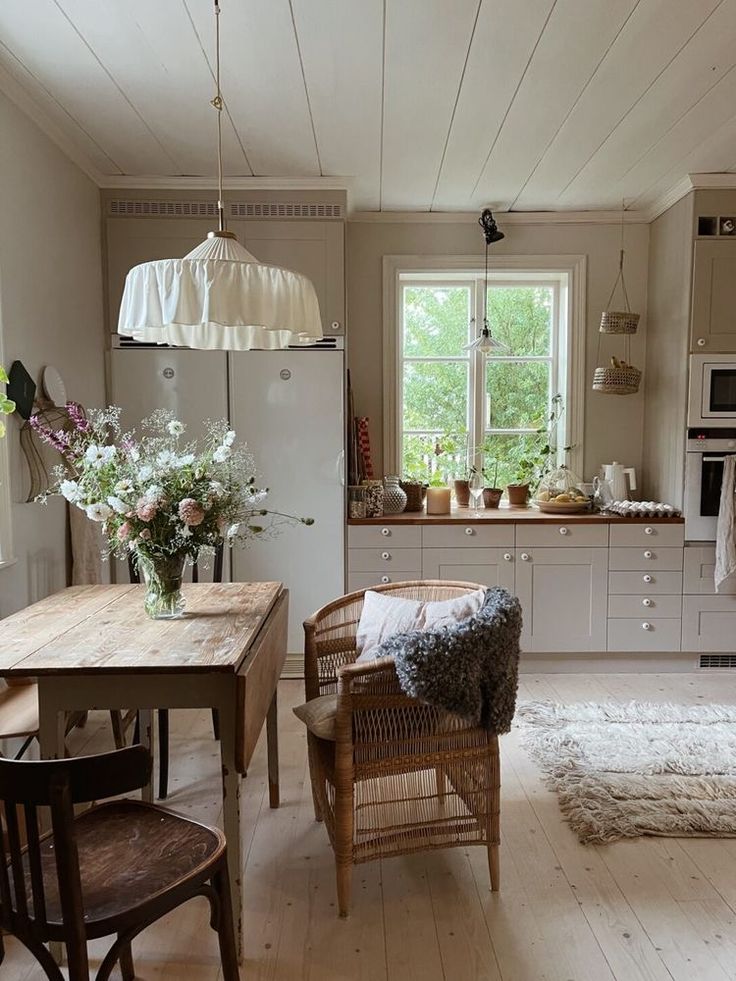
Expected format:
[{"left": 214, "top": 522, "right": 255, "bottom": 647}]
[{"left": 355, "top": 589, "right": 486, "bottom": 661}]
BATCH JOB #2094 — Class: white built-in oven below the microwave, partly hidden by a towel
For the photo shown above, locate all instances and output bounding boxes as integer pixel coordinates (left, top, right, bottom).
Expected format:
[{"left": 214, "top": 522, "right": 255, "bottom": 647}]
[{"left": 684, "top": 427, "right": 736, "bottom": 542}]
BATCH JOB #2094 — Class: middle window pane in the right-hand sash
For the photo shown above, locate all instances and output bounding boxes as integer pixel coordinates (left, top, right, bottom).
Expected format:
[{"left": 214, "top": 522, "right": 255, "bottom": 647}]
[{"left": 486, "top": 358, "right": 550, "bottom": 429}]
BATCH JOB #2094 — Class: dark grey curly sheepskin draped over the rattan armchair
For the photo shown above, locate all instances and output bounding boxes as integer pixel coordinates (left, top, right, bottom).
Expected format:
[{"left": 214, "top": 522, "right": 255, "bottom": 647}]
[{"left": 375, "top": 587, "right": 521, "bottom": 733}]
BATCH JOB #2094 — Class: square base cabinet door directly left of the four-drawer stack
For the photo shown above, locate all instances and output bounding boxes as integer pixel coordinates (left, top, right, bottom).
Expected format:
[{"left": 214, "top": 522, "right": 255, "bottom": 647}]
[{"left": 516, "top": 548, "right": 608, "bottom": 652}]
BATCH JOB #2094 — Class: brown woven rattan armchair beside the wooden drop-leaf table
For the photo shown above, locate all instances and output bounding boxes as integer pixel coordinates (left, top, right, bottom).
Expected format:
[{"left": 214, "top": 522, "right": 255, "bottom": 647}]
[{"left": 304, "top": 580, "right": 500, "bottom": 916}]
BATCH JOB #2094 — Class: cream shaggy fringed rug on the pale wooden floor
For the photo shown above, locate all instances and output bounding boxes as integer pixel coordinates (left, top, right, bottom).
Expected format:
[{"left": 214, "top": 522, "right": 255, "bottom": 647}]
[{"left": 516, "top": 702, "right": 736, "bottom": 843}]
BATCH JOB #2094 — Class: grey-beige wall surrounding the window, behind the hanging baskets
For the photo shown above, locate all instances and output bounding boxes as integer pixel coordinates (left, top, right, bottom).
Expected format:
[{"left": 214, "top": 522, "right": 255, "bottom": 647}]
[{"left": 347, "top": 215, "right": 649, "bottom": 486}]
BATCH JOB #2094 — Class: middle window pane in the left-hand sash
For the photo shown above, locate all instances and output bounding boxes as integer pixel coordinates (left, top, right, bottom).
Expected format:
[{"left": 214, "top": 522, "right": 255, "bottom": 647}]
[{"left": 403, "top": 361, "right": 468, "bottom": 433}]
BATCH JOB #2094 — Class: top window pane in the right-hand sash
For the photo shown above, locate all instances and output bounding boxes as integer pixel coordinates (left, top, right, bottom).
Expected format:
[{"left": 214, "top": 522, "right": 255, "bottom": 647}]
[{"left": 487, "top": 286, "right": 553, "bottom": 357}]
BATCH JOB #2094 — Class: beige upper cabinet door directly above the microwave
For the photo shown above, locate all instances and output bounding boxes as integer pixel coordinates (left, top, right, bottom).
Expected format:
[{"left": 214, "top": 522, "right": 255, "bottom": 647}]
[{"left": 691, "top": 239, "right": 736, "bottom": 353}]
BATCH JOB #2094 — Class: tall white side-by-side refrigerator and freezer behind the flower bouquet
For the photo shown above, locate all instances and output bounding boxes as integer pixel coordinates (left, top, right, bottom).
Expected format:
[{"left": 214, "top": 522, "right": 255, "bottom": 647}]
[{"left": 110, "top": 338, "right": 345, "bottom": 655}]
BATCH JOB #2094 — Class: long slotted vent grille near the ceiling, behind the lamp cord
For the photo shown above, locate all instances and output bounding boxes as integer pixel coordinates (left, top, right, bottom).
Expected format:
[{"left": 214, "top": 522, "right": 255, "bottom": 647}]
[{"left": 107, "top": 198, "right": 343, "bottom": 220}]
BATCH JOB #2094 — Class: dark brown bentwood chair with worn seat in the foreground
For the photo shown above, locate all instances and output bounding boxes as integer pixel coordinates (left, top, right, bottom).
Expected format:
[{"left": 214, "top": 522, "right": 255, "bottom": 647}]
[{"left": 0, "top": 746, "right": 239, "bottom": 981}]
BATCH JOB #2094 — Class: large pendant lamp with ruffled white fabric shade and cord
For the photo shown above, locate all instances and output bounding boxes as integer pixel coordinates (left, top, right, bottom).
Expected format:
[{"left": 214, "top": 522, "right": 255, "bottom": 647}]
[{"left": 118, "top": 0, "right": 322, "bottom": 351}]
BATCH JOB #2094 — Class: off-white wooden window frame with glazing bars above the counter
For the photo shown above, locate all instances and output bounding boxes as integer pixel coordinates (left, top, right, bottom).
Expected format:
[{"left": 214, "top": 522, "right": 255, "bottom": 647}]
[{"left": 383, "top": 255, "right": 586, "bottom": 475}]
